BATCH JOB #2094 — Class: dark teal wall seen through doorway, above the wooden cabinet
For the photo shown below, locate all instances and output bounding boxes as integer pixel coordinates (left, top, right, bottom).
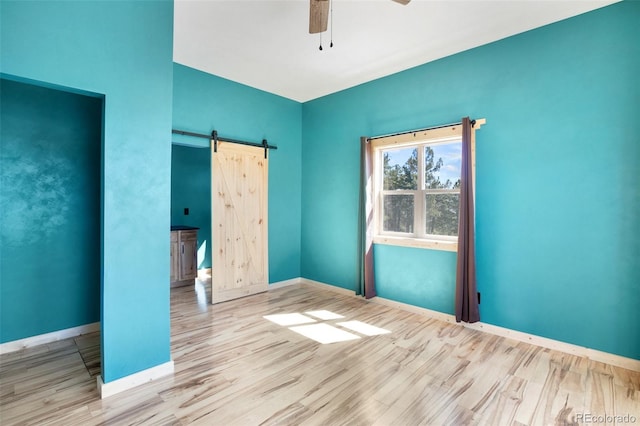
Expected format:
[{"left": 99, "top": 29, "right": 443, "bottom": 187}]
[{"left": 171, "top": 144, "right": 211, "bottom": 269}]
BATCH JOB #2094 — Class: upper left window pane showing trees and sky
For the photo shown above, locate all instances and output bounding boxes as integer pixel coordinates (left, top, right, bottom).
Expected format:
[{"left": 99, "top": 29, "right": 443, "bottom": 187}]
[{"left": 382, "top": 148, "right": 418, "bottom": 190}]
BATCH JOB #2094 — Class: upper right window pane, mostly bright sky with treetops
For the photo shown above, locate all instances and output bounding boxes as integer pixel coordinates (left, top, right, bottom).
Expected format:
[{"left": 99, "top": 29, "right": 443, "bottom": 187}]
[{"left": 424, "top": 141, "right": 462, "bottom": 189}]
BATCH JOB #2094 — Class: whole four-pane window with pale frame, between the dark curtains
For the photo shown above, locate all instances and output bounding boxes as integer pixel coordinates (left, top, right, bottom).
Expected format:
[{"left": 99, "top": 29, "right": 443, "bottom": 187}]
[{"left": 372, "top": 126, "right": 470, "bottom": 250}]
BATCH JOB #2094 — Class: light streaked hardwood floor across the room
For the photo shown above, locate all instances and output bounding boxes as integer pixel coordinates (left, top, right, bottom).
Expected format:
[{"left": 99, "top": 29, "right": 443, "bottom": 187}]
[{"left": 0, "top": 284, "right": 640, "bottom": 426}]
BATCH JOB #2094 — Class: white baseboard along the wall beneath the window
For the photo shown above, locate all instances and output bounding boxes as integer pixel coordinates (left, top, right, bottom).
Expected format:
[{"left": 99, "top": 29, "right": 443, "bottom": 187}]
[{"left": 300, "top": 278, "right": 640, "bottom": 372}]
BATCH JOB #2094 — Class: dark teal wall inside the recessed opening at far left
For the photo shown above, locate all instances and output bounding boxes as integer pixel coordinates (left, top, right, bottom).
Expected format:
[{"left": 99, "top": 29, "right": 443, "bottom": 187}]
[{"left": 0, "top": 79, "right": 102, "bottom": 343}]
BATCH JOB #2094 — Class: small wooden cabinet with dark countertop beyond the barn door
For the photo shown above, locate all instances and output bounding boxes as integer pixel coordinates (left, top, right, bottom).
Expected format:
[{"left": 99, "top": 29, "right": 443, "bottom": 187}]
[{"left": 171, "top": 229, "right": 198, "bottom": 287}]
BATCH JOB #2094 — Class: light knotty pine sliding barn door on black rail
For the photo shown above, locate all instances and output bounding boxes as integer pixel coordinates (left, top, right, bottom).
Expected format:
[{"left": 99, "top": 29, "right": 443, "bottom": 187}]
[{"left": 211, "top": 141, "right": 269, "bottom": 303}]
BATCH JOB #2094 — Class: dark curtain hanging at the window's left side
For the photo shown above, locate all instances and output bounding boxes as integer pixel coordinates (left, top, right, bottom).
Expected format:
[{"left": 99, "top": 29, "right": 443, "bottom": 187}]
[{"left": 358, "top": 137, "right": 376, "bottom": 299}]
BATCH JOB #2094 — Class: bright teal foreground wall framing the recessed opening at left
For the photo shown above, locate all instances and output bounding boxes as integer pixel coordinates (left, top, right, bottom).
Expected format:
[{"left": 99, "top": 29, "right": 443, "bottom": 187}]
[{"left": 0, "top": 0, "right": 173, "bottom": 382}]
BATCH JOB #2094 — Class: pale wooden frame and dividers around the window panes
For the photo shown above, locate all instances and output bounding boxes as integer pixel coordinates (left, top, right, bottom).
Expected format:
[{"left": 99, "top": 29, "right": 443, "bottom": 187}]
[{"left": 371, "top": 124, "right": 475, "bottom": 251}]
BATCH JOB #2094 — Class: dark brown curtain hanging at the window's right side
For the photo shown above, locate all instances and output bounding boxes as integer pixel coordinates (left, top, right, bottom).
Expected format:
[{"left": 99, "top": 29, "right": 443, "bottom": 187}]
[{"left": 456, "top": 117, "right": 480, "bottom": 323}]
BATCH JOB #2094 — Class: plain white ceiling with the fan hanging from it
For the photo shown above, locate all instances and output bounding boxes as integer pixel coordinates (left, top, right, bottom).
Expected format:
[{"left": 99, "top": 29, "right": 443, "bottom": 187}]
[{"left": 173, "top": 0, "right": 618, "bottom": 102}]
